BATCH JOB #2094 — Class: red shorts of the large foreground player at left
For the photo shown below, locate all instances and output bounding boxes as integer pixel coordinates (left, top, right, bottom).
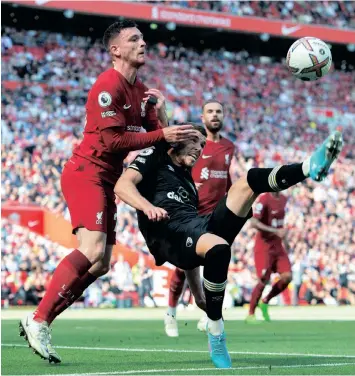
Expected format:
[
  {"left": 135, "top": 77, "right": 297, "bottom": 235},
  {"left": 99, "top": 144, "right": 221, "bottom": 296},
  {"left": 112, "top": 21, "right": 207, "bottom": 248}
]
[{"left": 61, "top": 157, "right": 117, "bottom": 245}]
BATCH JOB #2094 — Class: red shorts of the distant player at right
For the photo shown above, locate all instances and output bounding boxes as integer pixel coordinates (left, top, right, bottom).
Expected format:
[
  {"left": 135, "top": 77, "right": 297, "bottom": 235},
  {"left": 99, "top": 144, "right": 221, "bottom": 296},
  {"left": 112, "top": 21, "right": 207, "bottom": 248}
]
[{"left": 254, "top": 246, "right": 291, "bottom": 280}]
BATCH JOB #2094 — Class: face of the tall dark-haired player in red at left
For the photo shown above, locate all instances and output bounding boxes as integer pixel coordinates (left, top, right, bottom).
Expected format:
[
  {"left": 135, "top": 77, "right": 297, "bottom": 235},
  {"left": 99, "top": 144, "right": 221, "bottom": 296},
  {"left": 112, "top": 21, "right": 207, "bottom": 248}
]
[{"left": 113, "top": 27, "right": 146, "bottom": 68}]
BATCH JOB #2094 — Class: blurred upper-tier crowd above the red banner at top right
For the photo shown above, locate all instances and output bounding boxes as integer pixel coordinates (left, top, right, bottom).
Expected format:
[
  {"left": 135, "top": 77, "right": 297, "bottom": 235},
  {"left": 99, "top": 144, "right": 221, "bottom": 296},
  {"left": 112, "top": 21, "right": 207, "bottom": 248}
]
[{"left": 149, "top": 0, "right": 355, "bottom": 28}]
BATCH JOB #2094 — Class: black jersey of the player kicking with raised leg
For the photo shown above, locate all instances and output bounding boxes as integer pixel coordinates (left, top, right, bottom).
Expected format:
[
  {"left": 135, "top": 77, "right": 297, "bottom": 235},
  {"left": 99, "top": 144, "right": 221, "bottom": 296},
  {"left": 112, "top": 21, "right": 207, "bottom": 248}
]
[{"left": 128, "top": 146, "right": 204, "bottom": 264}]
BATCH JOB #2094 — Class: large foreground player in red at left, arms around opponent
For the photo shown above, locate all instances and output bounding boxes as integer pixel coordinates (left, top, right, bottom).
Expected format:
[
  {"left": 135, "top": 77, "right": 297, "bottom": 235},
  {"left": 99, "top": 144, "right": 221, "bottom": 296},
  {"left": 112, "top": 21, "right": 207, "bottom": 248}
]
[{"left": 20, "top": 20, "right": 196, "bottom": 363}]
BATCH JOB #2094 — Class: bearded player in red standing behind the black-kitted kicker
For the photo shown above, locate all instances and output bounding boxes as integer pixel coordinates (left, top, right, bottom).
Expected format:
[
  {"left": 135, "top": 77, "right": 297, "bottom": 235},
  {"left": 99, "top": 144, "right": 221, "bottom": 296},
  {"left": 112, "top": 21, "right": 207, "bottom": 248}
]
[{"left": 164, "top": 100, "right": 234, "bottom": 337}]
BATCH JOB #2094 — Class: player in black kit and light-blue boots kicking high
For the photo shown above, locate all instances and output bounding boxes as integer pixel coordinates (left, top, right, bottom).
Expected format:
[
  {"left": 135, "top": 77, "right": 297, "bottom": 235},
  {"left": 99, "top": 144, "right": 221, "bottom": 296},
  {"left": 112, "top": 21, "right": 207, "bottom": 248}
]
[{"left": 115, "top": 125, "right": 342, "bottom": 368}]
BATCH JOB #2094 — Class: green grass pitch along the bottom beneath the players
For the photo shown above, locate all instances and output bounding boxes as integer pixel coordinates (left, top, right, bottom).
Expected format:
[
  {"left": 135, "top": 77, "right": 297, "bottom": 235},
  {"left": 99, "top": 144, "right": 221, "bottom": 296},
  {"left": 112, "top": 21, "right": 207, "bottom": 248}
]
[{"left": 1, "top": 320, "right": 355, "bottom": 375}]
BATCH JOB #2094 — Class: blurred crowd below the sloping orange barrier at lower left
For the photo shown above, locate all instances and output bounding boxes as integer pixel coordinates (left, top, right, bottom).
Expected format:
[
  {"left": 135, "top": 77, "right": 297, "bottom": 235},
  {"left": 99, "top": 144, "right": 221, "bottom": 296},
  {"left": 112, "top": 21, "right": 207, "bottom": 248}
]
[{"left": 1, "top": 218, "right": 156, "bottom": 307}]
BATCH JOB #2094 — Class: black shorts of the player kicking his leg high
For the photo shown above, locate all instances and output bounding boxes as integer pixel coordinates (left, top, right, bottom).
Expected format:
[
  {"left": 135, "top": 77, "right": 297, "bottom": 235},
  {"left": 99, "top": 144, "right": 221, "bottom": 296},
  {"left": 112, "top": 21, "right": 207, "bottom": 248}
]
[{"left": 148, "top": 196, "right": 252, "bottom": 270}]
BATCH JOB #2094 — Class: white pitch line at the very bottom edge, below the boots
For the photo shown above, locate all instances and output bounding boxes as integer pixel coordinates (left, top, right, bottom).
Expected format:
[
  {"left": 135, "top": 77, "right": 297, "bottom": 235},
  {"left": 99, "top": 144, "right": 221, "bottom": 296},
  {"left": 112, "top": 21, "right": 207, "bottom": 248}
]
[{"left": 4, "top": 363, "right": 355, "bottom": 376}]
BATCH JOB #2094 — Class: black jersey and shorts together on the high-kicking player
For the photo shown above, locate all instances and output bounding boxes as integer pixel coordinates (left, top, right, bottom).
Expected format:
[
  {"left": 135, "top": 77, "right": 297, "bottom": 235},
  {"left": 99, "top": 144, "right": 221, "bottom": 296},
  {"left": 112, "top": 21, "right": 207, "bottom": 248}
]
[{"left": 128, "top": 142, "right": 250, "bottom": 270}]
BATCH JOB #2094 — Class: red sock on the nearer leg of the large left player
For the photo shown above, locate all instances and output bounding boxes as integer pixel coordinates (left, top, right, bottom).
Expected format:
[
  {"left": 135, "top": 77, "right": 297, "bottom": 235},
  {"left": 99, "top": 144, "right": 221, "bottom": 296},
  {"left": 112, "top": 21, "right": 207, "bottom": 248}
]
[{"left": 34, "top": 249, "right": 92, "bottom": 321}]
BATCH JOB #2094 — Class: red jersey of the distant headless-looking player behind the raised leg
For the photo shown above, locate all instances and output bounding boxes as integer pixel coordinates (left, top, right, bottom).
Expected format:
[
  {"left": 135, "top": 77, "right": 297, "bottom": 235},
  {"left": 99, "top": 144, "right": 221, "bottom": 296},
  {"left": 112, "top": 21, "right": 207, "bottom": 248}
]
[{"left": 253, "top": 193, "right": 287, "bottom": 248}]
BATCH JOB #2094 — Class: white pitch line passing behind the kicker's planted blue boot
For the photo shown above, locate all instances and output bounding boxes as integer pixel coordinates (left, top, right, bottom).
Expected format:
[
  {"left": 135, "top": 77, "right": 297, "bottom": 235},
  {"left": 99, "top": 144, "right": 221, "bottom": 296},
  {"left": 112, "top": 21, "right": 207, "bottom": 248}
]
[{"left": 1, "top": 343, "right": 355, "bottom": 359}]
